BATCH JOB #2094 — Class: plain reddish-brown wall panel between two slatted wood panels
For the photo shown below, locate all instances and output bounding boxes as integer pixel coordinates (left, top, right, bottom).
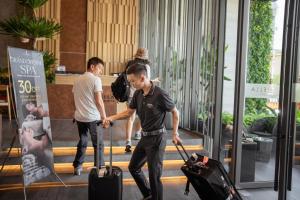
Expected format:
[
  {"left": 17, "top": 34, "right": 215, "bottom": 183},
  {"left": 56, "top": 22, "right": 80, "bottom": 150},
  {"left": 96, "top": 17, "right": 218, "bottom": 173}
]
[{"left": 60, "top": 0, "right": 88, "bottom": 73}]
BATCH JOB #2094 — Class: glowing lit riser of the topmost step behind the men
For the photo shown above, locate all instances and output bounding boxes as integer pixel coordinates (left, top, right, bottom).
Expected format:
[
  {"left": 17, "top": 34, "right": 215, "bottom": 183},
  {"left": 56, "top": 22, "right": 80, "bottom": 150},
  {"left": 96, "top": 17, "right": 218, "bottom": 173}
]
[{"left": 0, "top": 145, "right": 203, "bottom": 158}]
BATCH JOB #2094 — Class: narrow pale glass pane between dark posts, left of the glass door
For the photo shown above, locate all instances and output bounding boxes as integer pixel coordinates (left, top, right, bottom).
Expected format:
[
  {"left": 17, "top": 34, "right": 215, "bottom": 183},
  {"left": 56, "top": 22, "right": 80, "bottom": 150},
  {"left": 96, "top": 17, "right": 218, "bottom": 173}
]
[{"left": 220, "top": 0, "right": 239, "bottom": 172}]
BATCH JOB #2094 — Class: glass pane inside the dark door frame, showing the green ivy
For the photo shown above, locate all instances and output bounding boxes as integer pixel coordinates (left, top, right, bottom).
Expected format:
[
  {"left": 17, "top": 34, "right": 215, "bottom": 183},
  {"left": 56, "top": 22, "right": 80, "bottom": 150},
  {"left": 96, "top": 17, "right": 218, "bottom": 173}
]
[{"left": 240, "top": 0, "right": 284, "bottom": 182}]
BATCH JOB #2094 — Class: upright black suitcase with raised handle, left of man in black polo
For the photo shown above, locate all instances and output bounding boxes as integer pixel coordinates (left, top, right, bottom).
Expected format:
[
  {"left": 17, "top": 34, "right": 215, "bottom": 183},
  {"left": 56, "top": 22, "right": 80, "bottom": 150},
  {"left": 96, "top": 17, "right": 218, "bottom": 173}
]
[{"left": 88, "top": 121, "right": 123, "bottom": 200}]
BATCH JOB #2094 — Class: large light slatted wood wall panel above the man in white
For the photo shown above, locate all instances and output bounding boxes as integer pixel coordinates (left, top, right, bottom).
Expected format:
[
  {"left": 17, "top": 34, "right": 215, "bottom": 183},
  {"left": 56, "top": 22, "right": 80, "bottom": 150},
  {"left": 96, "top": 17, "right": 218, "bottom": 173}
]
[{"left": 86, "top": 0, "right": 139, "bottom": 75}]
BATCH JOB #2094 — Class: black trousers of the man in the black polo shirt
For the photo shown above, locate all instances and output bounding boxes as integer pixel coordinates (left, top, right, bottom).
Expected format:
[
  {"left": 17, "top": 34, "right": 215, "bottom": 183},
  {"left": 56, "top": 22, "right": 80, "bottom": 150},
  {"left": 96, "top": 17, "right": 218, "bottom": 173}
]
[{"left": 128, "top": 134, "right": 166, "bottom": 200}]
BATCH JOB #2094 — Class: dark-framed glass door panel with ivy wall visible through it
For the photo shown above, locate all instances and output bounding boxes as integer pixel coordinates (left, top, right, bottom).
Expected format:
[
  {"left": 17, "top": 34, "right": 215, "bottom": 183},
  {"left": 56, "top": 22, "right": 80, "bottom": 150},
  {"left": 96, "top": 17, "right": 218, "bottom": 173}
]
[{"left": 229, "top": 0, "right": 286, "bottom": 188}]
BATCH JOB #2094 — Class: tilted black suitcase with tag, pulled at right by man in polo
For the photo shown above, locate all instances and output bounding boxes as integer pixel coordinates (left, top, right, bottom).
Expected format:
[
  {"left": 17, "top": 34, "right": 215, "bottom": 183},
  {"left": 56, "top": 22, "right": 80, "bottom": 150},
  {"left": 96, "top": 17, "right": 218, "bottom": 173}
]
[{"left": 175, "top": 144, "right": 242, "bottom": 200}]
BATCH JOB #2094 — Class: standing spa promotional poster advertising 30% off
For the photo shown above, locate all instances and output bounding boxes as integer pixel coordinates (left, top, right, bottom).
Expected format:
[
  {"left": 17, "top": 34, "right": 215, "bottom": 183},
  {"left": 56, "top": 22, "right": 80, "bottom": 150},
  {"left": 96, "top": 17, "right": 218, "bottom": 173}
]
[{"left": 8, "top": 47, "right": 54, "bottom": 186}]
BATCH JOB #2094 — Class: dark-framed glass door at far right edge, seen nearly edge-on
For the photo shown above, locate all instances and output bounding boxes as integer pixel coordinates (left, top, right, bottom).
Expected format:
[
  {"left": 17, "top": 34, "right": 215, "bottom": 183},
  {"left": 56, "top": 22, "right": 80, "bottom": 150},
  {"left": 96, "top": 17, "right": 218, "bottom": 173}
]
[{"left": 274, "top": 1, "right": 300, "bottom": 200}]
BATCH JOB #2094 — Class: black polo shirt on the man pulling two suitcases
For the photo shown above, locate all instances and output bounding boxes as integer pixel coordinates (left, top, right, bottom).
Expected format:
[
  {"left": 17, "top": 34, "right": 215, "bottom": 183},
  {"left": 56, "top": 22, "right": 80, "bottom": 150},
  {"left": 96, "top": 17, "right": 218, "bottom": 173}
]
[{"left": 129, "top": 82, "right": 175, "bottom": 132}]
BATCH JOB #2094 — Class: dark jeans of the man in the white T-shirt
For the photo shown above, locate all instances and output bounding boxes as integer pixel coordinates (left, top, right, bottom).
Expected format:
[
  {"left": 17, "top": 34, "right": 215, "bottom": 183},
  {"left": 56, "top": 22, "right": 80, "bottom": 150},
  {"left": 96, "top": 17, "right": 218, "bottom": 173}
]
[{"left": 73, "top": 121, "right": 104, "bottom": 168}]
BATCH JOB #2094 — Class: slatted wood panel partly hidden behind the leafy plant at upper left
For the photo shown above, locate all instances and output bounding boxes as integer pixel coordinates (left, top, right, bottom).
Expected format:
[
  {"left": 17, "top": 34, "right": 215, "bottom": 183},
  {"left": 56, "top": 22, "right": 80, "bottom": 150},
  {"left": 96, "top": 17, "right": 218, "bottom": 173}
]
[{"left": 37, "top": 0, "right": 61, "bottom": 63}]
